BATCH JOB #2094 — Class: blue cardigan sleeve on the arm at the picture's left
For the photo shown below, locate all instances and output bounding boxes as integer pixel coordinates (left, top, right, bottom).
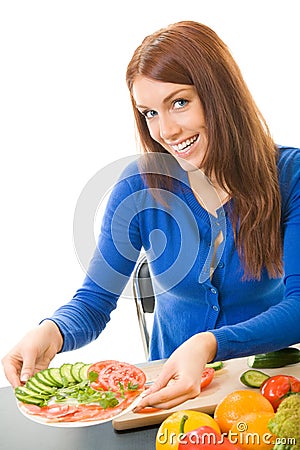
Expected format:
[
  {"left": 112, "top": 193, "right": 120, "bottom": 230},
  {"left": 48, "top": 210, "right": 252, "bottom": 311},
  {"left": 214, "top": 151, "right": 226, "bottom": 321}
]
[{"left": 44, "top": 165, "right": 141, "bottom": 352}]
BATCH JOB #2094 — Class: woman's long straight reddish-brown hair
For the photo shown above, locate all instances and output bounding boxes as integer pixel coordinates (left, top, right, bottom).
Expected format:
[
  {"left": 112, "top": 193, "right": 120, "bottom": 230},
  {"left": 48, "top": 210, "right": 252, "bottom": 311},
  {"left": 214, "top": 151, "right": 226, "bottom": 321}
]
[{"left": 126, "top": 21, "right": 282, "bottom": 280}]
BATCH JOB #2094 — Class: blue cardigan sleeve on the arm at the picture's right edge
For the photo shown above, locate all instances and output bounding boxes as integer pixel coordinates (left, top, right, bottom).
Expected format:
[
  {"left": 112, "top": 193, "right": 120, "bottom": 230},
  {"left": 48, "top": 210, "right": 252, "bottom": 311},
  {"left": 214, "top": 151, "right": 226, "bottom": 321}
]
[{"left": 211, "top": 149, "right": 300, "bottom": 360}]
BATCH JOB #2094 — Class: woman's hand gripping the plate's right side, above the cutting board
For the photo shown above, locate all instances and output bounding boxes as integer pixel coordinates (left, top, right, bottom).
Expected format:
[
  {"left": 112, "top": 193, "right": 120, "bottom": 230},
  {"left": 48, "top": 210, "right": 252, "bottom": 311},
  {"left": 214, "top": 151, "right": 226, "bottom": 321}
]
[{"left": 134, "top": 332, "right": 217, "bottom": 412}]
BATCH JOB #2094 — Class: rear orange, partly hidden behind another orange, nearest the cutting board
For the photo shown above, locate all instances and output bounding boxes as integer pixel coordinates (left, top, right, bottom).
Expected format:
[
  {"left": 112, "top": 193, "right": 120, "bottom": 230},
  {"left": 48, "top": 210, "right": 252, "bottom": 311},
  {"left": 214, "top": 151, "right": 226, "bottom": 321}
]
[{"left": 214, "top": 389, "right": 274, "bottom": 433}]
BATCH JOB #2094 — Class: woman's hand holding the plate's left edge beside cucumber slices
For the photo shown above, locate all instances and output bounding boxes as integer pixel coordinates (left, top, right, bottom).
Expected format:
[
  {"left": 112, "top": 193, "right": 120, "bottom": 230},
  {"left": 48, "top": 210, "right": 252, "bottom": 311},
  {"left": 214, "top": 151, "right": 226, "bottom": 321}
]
[{"left": 2, "top": 320, "right": 63, "bottom": 388}]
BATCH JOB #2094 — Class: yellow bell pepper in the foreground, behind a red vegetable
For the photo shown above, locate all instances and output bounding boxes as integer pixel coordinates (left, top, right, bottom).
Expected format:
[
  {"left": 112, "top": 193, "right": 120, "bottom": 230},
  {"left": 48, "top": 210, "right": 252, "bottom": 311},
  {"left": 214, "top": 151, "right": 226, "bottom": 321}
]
[{"left": 155, "top": 409, "right": 221, "bottom": 450}]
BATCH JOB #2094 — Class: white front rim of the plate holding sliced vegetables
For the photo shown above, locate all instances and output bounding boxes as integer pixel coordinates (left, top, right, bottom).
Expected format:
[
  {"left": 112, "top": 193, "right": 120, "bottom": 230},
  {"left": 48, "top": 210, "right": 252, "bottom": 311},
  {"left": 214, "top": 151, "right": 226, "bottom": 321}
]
[{"left": 17, "top": 391, "right": 145, "bottom": 428}]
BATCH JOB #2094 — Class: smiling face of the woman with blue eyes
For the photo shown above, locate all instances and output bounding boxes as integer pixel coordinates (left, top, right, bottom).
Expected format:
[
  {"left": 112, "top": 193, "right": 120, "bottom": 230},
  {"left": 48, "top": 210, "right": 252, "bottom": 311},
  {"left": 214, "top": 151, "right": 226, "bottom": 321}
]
[{"left": 133, "top": 76, "right": 207, "bottom": 170}]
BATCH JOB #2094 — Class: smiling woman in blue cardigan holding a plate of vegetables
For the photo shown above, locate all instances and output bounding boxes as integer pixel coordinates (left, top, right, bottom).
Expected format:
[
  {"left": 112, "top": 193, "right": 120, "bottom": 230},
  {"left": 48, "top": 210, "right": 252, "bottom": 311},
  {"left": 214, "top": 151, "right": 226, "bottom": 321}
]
[{"left": 3, "top": 21, "right": 300, "bottom": 408}]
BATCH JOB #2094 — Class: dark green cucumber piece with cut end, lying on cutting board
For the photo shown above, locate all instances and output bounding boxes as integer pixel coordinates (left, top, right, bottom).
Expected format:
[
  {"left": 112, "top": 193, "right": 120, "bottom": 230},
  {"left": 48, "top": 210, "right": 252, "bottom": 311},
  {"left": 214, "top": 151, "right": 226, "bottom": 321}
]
[{"left": 247, "top": 347, "right": 300, "bottom": 369}]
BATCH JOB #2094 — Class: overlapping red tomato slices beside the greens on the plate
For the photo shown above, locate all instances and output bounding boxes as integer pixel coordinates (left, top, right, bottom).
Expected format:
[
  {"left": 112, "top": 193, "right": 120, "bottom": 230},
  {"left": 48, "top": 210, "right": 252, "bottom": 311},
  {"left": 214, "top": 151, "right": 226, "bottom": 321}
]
[{"left": 88, "top": 360, "right": 146, "bottom": 392}]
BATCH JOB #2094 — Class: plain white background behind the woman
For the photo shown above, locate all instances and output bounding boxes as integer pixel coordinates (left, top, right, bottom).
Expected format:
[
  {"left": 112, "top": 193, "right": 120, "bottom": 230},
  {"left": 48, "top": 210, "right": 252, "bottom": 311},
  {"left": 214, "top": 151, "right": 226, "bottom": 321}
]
[{"left": 0, "top": 0, "right": 300, "bottom": 386}]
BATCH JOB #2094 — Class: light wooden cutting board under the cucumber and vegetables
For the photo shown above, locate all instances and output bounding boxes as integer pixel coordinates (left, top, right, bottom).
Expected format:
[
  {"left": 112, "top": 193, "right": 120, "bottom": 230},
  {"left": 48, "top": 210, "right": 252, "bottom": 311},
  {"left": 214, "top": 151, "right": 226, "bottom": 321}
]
[{"left": 112, "top": 352, "right": 300, "bottom": 430}]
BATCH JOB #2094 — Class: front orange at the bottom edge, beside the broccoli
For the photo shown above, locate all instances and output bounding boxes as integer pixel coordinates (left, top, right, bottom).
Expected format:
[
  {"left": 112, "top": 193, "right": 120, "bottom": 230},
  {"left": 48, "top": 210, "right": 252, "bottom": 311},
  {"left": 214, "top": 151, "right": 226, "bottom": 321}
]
[{"left": 228, "top": 411, "right": 276, "bottom": 450}]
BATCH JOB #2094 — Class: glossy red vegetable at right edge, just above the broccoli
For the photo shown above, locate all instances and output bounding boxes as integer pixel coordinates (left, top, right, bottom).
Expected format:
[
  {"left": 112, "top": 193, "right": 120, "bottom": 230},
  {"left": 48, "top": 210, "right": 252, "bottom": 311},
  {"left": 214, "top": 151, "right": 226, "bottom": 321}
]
[{"left": 260, "top": 375, "right": 300, "bottom": 411}]
